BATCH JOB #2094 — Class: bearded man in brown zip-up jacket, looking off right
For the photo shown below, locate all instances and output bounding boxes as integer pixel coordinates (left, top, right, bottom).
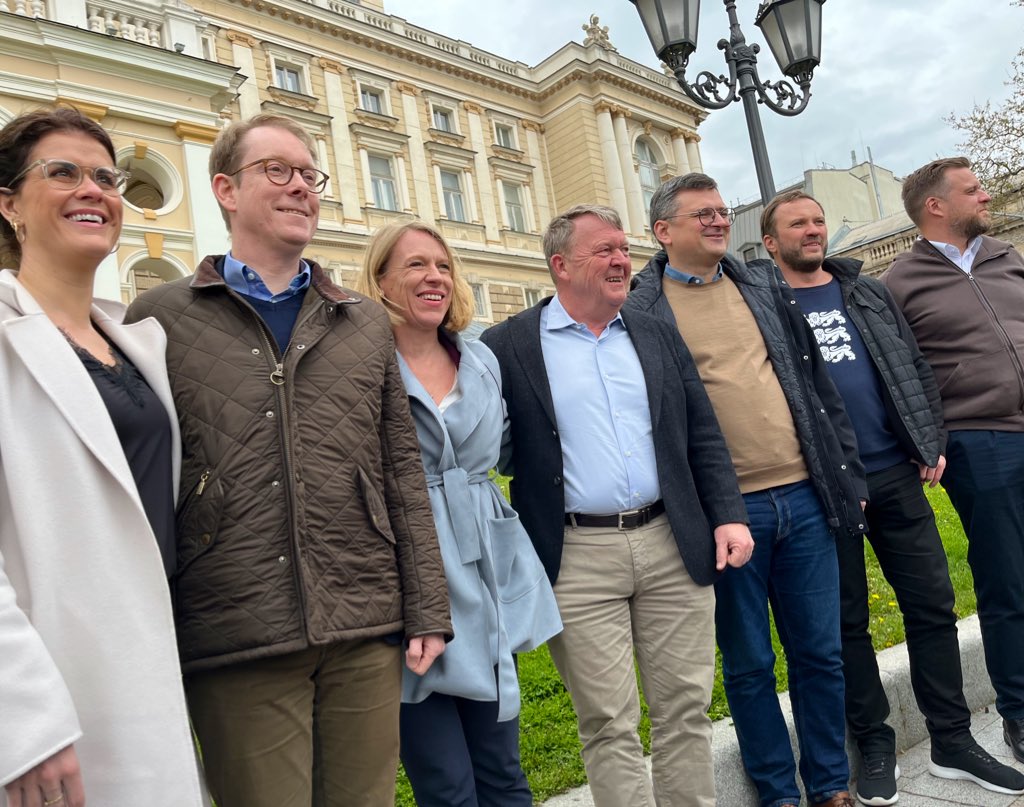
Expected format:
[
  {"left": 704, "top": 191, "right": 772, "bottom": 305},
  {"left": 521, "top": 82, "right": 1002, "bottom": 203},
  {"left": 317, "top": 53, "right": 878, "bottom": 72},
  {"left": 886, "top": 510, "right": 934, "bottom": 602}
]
[{"left": 882, "top": 158, "right": 1024, "bottom": 762}]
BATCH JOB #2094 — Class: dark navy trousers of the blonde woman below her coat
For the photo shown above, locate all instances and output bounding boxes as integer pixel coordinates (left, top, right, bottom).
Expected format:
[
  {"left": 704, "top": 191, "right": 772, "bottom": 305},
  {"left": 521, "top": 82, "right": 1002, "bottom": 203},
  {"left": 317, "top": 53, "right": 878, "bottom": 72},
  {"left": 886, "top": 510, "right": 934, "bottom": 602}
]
[{"left": 399, "top": 692, "right": 534, "bottom": 807}]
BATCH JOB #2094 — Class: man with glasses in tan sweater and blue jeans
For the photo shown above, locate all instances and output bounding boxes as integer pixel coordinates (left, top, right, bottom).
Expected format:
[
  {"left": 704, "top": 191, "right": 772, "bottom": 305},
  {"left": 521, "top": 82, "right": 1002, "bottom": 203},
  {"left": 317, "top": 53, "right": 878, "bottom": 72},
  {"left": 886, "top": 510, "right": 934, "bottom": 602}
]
[{"left": 626, "top": 173, "right": 867, "bottom": 807}]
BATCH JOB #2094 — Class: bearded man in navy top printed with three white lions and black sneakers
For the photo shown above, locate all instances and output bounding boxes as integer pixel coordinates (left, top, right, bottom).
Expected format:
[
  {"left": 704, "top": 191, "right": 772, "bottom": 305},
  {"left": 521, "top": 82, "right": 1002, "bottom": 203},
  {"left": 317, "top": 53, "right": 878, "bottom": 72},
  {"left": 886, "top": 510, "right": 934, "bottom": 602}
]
[{"left": 761, "top": 190, "right": 1024, "bottom": 805}]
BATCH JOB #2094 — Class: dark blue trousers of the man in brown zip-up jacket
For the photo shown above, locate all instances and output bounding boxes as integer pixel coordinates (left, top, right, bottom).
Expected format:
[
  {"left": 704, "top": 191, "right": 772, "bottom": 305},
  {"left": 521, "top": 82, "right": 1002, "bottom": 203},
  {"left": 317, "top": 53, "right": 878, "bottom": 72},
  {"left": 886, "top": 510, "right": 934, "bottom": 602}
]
[{"left": 942, "top": 430, "right": 1024, "bottom": 719}]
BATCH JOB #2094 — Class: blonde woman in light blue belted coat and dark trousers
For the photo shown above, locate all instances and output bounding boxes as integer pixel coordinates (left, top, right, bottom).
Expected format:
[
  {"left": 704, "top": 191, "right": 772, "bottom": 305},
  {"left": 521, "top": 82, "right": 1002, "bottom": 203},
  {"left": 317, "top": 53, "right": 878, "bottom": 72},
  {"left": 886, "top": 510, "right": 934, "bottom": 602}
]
[{"left": 362, "top": 220, "right": 561, "bottom": 807}]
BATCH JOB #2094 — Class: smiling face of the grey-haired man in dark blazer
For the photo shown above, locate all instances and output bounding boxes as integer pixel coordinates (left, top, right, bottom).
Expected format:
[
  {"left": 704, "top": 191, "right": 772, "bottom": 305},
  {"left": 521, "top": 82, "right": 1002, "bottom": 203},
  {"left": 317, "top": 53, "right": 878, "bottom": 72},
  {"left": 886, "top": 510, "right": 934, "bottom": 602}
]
[{"left": 551, "top": 214, "right": 633, "bottom": 330}]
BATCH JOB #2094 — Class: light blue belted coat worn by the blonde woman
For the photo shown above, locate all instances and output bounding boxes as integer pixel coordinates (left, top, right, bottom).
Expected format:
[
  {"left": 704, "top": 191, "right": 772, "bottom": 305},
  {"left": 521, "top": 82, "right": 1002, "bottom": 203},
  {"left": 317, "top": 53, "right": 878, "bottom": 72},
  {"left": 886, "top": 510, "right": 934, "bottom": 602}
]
[{"left": 398, "top": 337, "right": 562, "bottom": 721}]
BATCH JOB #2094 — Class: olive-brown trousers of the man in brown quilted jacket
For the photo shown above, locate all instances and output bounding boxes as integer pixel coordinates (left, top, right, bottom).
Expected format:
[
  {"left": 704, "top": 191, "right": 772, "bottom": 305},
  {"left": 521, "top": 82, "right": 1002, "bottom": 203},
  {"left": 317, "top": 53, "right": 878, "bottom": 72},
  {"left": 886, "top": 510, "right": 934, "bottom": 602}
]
[{"left": 185, "top": 639, "right": 401, "bottom": 807}]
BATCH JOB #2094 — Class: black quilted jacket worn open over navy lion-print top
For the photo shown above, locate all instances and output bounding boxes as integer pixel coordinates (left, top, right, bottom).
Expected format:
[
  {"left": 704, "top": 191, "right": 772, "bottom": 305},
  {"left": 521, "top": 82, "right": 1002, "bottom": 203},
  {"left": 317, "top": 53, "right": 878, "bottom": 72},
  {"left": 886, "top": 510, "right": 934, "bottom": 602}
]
[{"left": 811, "top": 258, "right": 946, "bottom": 468}]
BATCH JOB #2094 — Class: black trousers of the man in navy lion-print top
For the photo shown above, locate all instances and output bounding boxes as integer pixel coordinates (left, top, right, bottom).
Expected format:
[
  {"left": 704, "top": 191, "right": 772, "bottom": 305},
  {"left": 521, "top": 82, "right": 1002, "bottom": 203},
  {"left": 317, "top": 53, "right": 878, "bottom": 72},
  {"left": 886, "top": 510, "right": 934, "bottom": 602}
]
[{"left": 839, "top": 463, "right": 974, "bottom": 754}]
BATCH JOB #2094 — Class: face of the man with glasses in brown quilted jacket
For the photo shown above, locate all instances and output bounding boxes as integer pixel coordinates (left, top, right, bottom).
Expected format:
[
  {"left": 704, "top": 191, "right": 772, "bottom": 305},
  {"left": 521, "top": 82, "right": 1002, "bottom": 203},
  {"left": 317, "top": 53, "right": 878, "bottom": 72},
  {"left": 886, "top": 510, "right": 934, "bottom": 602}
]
[{"left": 213, "top": 126, "right": 319, "bottom": 261}]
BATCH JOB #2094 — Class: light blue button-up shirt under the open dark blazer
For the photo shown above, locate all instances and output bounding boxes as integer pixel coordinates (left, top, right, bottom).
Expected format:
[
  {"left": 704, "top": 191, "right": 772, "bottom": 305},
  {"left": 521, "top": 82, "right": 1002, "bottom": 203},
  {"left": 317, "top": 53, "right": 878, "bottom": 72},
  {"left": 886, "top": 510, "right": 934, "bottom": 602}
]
[{"left": 541, "top": 295, "right": 662, "bottom": 515}]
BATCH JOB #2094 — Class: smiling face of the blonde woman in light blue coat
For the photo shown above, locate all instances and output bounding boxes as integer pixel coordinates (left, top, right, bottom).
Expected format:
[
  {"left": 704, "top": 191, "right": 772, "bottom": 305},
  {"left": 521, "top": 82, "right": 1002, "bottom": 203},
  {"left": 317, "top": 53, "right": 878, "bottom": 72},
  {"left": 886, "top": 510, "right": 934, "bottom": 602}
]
[{"left": 380, "top": 229, "right": 453, "bottom": 333}]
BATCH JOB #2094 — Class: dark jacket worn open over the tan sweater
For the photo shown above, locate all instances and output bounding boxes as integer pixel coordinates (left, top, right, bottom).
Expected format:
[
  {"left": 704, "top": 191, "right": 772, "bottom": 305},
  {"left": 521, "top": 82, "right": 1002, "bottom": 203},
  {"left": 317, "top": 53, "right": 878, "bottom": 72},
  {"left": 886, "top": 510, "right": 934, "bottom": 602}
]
[{"left": 625, "top": 250, "right": 867, "bottom": 535}]
